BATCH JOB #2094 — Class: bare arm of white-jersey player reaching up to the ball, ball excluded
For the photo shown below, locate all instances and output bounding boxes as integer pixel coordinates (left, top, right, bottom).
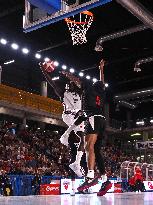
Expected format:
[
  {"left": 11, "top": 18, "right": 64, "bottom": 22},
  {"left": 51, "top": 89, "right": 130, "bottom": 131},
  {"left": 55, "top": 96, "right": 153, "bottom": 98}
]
[{"left": 39, "top": 63, "right": 63, "bottom": 98}]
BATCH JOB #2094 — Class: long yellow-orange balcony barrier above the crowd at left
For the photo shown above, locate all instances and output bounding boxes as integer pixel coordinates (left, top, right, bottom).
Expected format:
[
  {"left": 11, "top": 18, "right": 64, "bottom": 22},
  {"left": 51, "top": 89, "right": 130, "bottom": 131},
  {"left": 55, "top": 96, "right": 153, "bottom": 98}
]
[{"left": 0, "top": 84, "right": 63, "bottom": 115}]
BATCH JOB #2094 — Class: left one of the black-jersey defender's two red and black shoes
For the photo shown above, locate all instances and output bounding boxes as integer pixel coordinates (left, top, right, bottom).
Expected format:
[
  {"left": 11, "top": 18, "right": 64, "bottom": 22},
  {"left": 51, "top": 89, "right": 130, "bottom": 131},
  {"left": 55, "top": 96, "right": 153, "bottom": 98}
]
[{"left": 77, "top": 177, "right": 98, "bottom": 192}]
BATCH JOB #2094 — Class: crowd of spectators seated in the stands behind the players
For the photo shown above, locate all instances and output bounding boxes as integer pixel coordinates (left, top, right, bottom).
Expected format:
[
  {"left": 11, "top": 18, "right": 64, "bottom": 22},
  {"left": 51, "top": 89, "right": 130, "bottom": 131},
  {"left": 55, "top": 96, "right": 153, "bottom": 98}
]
[{"left": 0, "top": 121, "right": 145, "bottom": 177}]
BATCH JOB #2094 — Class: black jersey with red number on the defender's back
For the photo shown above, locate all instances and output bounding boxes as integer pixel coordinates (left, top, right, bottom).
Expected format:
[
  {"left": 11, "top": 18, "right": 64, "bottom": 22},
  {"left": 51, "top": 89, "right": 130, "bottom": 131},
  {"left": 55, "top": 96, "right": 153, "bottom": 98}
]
[{"left": 83, "top": 81, "right": 105, "bottom": 115}]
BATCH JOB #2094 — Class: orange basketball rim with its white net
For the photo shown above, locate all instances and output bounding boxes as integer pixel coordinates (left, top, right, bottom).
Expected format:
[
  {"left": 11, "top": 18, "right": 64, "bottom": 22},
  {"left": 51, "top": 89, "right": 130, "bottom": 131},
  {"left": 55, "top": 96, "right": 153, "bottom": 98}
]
[{"left": 65, "top": 11, "right": 93, "bottom": 45}]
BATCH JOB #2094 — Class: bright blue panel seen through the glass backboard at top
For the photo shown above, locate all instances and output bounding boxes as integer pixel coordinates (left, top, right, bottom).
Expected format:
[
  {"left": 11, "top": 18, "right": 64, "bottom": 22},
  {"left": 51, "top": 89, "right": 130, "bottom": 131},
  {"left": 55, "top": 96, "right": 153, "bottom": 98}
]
[{"left": 28, "top": 0, "right": 61, "bottom": 14}]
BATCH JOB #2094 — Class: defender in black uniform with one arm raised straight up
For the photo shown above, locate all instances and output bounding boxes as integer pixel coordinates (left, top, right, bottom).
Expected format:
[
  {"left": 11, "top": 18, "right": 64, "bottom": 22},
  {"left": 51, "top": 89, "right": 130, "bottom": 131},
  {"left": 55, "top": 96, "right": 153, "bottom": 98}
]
[{"left": 78, "top": 60, "right": 112, "bottom": 196}]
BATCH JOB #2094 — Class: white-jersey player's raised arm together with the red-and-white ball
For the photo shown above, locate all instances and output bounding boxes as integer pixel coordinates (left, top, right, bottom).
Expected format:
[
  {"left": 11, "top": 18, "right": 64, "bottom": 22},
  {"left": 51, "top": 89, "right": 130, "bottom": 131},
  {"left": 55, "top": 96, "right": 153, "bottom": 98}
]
[{"left": 39, "top": 61, "right": 63, "bottom": 98}]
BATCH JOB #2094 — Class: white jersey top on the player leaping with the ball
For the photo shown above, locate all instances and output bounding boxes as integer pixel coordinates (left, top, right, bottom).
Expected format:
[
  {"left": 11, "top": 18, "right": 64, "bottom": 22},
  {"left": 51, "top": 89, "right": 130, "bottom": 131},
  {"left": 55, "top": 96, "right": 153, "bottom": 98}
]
[{"left": 63, "top": 91, "right": 82, "bottom": 113}]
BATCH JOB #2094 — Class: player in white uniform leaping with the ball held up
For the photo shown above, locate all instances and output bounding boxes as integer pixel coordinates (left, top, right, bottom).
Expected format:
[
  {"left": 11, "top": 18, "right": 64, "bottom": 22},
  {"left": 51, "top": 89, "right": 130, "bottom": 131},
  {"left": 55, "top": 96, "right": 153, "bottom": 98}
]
[{"left": 40, "top": 61, "right": 84, "bottom": 181}]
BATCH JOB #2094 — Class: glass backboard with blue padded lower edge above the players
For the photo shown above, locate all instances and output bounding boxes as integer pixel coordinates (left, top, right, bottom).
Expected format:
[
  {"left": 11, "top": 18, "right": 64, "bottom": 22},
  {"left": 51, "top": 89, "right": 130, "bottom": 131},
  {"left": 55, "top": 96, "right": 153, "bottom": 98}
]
[{"left": 23, "top": 0, "right": 112, "bottom": 33}]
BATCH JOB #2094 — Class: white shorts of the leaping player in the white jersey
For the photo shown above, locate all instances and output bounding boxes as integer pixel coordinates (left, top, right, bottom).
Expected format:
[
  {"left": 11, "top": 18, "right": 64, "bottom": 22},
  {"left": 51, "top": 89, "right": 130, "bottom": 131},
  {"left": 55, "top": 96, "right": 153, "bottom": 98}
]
[{"left": 62, "top": 113, "right": 85, "bottom": 133}]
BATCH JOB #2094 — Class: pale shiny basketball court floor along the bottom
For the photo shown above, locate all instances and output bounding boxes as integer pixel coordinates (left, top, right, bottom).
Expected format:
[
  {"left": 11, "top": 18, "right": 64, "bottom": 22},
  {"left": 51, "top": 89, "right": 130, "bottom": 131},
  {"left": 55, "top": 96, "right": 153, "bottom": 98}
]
[{"left": 0, "top": 192, "right": 153, "bottom": 205}]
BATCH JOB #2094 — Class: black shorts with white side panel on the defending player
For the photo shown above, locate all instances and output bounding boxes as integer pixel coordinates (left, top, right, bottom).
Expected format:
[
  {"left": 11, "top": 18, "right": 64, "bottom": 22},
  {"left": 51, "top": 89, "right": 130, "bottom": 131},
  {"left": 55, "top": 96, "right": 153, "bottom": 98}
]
[{"left": 85, "top": 115, "right": 106, "bottom": 135}]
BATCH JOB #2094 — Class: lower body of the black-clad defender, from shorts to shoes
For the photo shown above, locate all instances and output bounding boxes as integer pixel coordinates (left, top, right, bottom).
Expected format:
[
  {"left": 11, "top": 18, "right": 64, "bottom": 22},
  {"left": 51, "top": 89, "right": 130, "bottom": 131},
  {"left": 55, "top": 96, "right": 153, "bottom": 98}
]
[{"left": 78, "top": 116, "right": 112, "bottom": 193}]
